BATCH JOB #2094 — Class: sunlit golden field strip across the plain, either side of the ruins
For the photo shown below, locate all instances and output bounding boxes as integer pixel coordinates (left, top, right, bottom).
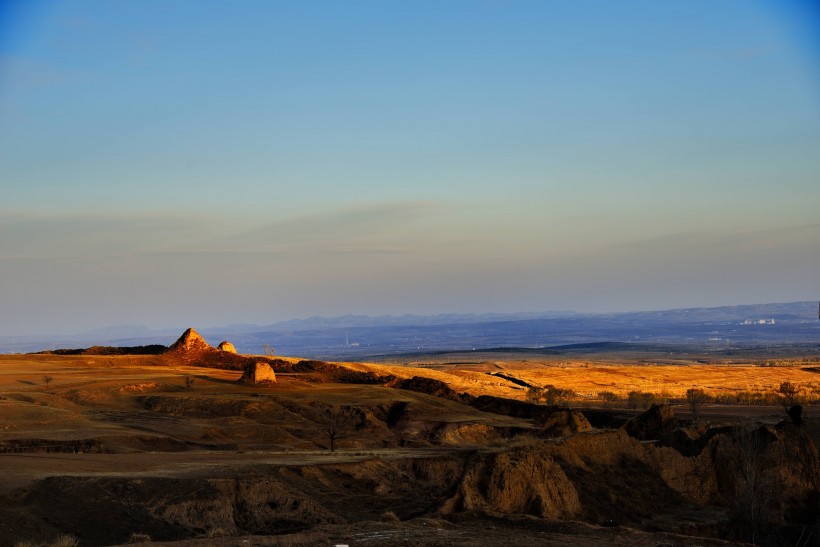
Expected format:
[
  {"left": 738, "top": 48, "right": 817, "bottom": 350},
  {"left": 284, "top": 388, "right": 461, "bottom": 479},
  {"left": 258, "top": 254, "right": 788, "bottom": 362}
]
[{"left": 0, "top": 355, "right": 820, "bottom": 406}]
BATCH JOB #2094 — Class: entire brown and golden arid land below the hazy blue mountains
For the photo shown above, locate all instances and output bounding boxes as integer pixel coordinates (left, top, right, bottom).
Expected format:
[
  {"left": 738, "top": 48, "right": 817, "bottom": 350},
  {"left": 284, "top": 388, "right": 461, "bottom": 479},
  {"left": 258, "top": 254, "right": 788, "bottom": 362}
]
[{"left": 0, "top": 332, "right": 820, "bottom": 546}]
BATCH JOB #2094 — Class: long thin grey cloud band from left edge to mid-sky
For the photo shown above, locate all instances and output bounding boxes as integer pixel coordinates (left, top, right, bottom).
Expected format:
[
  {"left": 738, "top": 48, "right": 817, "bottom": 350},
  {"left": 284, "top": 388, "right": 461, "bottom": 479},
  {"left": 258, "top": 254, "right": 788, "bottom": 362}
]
[{"left": 0, "top": 202, "right": 437, "bottom": 259}]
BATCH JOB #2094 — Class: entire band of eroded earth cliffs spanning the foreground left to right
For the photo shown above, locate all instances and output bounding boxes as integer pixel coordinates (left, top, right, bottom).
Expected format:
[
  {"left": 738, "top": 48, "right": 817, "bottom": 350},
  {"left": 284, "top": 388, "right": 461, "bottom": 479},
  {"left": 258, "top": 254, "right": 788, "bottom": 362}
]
[{"left": 0, "top": 427, "right": 813, "bottom": 545}]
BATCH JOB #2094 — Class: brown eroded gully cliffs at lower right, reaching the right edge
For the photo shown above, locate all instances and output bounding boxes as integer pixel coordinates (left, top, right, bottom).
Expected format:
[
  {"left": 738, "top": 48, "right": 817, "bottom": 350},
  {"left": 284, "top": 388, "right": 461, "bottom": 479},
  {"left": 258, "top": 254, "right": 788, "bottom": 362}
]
[{"left": 439, "top": 424, "right": 818, "bottom": 544}]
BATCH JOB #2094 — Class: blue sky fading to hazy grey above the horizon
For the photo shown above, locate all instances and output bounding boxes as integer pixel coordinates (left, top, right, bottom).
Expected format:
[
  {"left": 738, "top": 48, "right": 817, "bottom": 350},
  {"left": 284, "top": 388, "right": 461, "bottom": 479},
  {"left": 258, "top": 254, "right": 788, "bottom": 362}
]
[{"left": 0, "top": 0, "right": 820, "bottom": 335}]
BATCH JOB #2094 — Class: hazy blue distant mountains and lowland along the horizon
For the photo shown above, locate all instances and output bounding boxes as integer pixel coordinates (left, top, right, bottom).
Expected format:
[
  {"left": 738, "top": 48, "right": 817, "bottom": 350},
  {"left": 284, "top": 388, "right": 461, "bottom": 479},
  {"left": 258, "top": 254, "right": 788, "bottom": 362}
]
[{"left": 0, "top": 301, "right": 820, "bottom": 360}]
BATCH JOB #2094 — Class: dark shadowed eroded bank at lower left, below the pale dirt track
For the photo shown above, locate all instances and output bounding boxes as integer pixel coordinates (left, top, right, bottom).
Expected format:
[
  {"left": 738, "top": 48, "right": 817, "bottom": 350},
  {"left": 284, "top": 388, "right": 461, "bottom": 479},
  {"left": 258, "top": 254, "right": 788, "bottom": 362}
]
[{"left": 0, "top": 455, "right": 464, "bottom": 545}]
